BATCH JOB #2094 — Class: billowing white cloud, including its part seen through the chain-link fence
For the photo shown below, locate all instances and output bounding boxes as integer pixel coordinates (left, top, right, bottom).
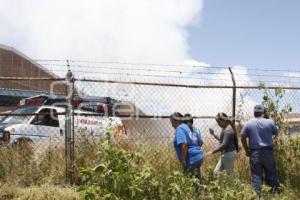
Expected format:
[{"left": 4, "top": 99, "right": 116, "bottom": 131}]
[{"left": 0, "top": 0, "right": 258, "bottom": 120}]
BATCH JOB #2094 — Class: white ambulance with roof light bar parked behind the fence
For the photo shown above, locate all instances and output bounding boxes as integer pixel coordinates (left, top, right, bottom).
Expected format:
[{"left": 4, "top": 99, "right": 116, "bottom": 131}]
[{"left": 0, "top": 95, "right": 127, "bottom": 146}]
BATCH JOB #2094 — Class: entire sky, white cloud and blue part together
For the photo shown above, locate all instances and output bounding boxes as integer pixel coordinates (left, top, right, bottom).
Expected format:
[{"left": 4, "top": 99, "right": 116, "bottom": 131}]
[{"left": 0, "top": 0, "right": 300, "bottom": 114}]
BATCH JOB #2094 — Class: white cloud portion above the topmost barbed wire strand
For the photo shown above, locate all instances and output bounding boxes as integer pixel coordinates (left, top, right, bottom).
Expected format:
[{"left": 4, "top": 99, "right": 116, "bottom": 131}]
[{"left": 0, "top": 0, "right": 203, "bottom": 63}]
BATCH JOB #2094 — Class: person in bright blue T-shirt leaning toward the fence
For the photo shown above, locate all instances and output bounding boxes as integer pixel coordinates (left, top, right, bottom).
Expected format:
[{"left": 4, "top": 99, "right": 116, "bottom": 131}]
[{"left": 170, "top": 112, "right": 204, "bottom": 179}]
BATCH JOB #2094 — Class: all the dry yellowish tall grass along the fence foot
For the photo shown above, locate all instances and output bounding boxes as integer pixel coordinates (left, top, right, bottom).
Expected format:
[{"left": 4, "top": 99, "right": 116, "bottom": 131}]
[{"left": 0, "top": 137, "right": 300, "bottom": 199}]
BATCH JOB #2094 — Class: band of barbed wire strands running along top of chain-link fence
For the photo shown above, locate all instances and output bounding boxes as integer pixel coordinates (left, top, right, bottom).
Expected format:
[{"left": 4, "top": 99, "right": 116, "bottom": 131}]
[{"left": 2, "top": 59, "right": 300, "bottom": 85}]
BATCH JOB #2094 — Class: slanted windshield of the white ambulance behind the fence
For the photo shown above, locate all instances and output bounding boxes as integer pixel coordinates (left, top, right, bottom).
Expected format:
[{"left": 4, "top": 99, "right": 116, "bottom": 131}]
[{"left": 0, "top": 107, "right": 38, "bottom": 124}]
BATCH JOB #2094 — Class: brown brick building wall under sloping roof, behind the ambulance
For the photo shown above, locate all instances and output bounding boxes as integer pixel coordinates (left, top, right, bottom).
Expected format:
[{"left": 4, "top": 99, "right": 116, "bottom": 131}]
[{"left": 0, "top": 44, "right": 66, "bottom": 112}]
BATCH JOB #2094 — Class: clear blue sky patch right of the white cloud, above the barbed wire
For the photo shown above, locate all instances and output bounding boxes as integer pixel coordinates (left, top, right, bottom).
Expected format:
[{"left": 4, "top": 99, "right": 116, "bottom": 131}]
[{"left": 188, "top": 0, "right": 300, "bottom": 71}]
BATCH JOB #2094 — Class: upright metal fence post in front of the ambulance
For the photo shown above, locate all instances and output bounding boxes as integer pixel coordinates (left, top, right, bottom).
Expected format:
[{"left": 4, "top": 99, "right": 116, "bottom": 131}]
[{"left": 65, "top": 65, "right": 74, "bottom": 184}]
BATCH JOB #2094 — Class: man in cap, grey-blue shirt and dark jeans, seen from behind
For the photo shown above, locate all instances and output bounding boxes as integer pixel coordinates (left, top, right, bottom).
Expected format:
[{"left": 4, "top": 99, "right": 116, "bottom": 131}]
[{"left": 241, "top": 105, "right": 279, "bottom": 193}]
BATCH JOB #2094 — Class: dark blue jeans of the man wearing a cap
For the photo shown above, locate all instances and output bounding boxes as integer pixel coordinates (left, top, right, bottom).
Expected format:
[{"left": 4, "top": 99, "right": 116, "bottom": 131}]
[{"left": 250, "top": 149, "right": 279, "bottom": 192}]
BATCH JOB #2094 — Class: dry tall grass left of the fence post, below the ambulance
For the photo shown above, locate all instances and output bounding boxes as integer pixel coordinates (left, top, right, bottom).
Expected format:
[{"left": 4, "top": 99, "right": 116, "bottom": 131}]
[{"left": 0, "top": 142, "right": 65, "bottom": 186}]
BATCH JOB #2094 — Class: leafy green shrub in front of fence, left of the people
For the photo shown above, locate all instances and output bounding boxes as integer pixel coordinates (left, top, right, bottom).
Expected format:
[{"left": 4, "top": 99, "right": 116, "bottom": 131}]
[{"left": 78, "top": 143, "right": 197, "bottom": 199}]
